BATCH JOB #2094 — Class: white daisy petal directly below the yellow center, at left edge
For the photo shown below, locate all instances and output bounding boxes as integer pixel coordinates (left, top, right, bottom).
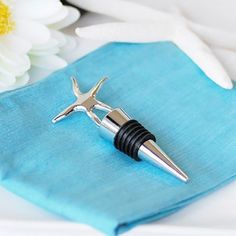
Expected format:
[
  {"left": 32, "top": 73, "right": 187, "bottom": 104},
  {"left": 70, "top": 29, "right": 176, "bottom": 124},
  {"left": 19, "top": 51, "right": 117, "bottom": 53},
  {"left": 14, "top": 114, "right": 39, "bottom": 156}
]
[{"left": 0, "top": 34, "right": 32, "bottom": 54}]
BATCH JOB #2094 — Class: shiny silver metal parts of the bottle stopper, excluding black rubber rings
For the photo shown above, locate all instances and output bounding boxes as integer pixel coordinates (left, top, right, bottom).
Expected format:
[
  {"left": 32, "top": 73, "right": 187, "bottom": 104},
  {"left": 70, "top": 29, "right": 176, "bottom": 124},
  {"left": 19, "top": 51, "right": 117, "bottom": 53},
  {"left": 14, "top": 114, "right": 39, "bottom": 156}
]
[{"left": 52, "top": 77, "right": 188, "bottom": 182}]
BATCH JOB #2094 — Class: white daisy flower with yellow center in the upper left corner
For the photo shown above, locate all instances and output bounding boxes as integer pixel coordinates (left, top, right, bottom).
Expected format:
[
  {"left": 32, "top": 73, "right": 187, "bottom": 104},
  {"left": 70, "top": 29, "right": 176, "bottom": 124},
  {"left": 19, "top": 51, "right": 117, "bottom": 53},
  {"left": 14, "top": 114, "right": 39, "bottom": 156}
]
[{"left": 0, "top": 0, "right": 80, "bottom": 91}]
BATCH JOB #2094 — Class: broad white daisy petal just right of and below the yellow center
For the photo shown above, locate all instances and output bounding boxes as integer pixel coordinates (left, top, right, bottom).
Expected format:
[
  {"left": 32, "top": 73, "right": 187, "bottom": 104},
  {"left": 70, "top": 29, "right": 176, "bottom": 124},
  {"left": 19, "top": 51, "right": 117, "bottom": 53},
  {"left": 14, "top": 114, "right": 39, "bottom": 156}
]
[{"left": 15, "top": 19, "right": 50, "bottom": 46}]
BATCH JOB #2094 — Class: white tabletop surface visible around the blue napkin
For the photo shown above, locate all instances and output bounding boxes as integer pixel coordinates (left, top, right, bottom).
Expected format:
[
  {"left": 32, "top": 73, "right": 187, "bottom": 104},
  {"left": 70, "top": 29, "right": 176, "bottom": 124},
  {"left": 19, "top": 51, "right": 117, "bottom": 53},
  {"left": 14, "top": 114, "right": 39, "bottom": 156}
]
[{"left": 0, "top": 0, "right": 236, "bottom": 236}]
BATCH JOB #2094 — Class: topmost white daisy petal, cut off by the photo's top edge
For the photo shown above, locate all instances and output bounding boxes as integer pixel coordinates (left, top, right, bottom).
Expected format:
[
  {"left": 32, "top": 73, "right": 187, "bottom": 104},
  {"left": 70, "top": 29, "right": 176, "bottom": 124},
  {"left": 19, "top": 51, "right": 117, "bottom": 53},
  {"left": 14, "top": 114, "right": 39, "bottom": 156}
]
[{"left": 13, "top": 0, "right": 62, "bottom": 20}]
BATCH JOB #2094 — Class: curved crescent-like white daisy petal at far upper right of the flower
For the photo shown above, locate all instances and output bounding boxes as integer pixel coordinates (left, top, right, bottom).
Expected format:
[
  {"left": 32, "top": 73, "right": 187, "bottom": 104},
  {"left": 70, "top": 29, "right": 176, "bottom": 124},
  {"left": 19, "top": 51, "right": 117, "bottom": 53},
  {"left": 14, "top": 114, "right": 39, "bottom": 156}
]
[{"left": 50, "top": 7, "right": 80, "bottom": 29}]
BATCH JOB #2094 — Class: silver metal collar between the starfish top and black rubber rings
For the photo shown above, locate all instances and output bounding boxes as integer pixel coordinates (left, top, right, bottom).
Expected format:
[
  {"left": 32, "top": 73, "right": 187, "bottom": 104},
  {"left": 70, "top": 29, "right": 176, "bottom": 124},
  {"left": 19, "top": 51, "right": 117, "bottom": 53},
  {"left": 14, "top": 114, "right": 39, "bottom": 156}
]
[{"left": 100, "top": 108, "right": 130, "bottom": 142}]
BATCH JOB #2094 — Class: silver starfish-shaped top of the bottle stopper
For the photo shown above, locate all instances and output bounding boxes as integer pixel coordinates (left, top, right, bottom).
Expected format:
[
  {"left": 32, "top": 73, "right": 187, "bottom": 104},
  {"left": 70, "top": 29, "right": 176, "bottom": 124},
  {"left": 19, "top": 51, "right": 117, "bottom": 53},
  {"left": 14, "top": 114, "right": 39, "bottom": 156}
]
[{"left": 52, "top": 77, "right": 112, "bottom": 126}]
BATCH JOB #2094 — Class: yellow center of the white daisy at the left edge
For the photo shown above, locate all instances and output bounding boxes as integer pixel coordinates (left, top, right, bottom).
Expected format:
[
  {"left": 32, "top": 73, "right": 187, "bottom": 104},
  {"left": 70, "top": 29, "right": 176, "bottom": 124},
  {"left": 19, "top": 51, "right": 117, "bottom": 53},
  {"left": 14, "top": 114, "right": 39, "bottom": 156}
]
[{"left": 0, "top": 0, "right": 15, "bottom": 35}]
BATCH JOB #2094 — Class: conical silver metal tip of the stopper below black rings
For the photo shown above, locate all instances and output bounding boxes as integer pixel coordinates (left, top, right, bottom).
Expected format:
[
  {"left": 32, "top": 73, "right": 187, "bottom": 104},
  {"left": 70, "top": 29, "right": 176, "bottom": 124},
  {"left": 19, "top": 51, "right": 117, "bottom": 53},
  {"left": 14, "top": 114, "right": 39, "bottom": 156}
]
[{"left": 138, "top": 140, "right": 189, "bottom": 182}]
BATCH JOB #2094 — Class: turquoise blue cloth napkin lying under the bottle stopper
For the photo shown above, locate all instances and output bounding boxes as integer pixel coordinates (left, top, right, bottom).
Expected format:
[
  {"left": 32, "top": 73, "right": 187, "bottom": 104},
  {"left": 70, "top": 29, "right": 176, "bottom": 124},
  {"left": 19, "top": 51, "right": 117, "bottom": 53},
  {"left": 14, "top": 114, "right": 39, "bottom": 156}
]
[{"left": 0, "top": 42, "right": 236, "bottom": 235}]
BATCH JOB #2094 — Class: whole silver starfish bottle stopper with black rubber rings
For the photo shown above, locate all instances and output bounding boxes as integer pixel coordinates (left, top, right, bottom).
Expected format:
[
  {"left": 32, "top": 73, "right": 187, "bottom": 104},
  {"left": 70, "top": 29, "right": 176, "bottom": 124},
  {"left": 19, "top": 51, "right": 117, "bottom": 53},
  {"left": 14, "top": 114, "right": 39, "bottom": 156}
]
[{"left": 52, "top": 77, "right": 188, "bottom": 182}]
